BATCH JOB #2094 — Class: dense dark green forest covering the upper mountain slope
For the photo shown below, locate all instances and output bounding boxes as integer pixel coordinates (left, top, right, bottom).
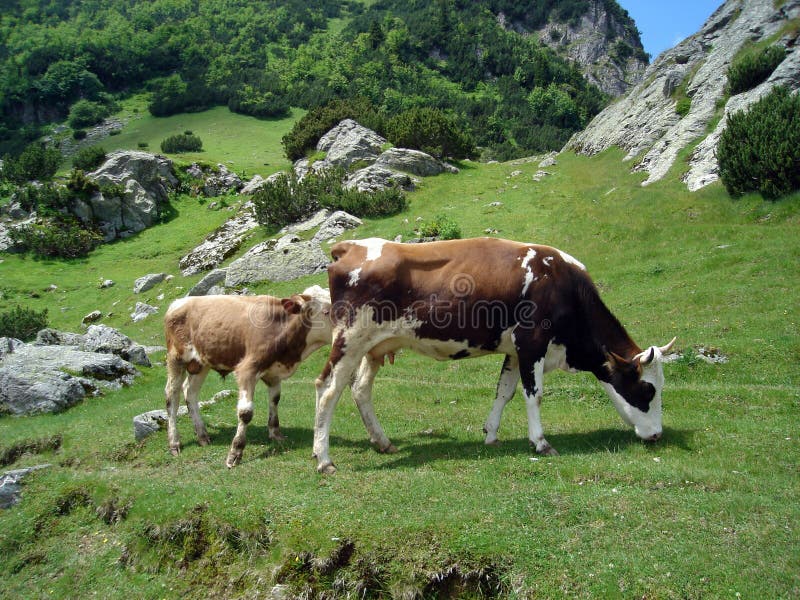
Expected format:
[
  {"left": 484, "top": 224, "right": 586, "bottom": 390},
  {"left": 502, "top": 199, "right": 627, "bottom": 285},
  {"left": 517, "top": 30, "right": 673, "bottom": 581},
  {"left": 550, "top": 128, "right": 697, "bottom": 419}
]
[{"left": 0, "top": 0, "right": 635, "bottom": 158}]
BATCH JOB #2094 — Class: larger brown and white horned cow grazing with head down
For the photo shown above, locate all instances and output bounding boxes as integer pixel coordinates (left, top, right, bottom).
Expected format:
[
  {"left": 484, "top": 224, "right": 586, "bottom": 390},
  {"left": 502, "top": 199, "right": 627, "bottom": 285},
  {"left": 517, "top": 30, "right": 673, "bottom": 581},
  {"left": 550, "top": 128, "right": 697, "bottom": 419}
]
[{"left": 314, "top": 238, "right": 675, "bottom": 473}]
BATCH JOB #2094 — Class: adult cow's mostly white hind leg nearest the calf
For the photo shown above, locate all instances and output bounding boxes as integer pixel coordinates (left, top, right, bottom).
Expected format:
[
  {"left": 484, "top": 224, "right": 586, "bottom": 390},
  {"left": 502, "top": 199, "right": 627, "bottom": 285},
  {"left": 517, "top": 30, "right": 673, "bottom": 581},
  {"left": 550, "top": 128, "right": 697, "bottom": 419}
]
[{"left": 313, "top": 350, "right": 361, "bottom": 475}]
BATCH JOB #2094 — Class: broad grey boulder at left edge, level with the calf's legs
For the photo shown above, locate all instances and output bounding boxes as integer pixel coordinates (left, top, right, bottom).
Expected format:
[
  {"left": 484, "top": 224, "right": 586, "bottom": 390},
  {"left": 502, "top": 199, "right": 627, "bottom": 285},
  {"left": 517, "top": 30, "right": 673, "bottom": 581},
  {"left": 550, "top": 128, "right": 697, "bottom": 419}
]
[{"left": 0, "top": 344, "right": 137, "bottom": 415}]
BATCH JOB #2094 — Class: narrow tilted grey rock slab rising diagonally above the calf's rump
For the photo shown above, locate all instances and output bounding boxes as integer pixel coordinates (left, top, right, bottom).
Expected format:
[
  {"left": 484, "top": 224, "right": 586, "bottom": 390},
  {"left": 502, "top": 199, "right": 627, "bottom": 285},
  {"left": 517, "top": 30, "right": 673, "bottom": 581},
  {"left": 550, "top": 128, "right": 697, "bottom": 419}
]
[{"left": 178, "top": 202, "right": 258, "bottom": 277}]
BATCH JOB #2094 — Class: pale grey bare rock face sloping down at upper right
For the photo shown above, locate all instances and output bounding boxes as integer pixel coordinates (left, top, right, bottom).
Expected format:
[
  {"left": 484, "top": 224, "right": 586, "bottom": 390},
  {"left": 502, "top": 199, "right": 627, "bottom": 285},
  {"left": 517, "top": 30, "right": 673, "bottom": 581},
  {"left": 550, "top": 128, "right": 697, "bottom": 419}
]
[{"left": 565, "top": 0, "right": 800, "bottom": 190}]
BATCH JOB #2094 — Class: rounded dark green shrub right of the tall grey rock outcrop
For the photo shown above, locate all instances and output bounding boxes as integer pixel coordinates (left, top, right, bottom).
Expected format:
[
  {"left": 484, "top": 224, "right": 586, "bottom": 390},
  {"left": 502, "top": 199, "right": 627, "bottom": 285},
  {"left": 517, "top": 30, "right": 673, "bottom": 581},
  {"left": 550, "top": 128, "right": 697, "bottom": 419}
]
[{"left": 386, "top": 108, "right": 475, "bottom": 158}]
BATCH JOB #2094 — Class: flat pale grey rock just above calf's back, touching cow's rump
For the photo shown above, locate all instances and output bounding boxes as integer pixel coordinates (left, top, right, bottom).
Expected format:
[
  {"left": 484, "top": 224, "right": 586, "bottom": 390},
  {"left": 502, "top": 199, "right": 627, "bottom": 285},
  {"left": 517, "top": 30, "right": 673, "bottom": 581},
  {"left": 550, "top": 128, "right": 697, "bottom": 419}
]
[{"left": 225, "top": 241, "right": 330, "bottom": 287}]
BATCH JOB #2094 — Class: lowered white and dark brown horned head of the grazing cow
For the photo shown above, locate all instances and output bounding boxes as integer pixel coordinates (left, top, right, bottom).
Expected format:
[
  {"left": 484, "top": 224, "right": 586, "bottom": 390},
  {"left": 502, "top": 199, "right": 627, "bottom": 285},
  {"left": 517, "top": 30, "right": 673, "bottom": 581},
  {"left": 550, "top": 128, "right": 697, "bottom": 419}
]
[{"left": 604, "top": 338, "right": 676, "bottom": 441}]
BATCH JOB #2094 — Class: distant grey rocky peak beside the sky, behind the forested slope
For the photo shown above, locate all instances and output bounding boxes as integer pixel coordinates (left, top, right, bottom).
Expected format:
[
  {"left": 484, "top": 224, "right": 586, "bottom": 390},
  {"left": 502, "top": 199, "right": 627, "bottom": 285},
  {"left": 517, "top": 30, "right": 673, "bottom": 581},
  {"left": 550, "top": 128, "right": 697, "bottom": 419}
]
[{"left": 498, "top": 0, "right": 648, "bottom": 97}]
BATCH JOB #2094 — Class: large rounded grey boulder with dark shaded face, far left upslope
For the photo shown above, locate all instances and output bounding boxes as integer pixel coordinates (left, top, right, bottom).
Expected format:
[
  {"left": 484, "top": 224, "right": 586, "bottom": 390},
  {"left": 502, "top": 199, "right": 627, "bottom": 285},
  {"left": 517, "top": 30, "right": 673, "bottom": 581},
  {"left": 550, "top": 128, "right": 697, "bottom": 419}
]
[{"left": 74, "top": 150, "right": 178, "bottom": 241}]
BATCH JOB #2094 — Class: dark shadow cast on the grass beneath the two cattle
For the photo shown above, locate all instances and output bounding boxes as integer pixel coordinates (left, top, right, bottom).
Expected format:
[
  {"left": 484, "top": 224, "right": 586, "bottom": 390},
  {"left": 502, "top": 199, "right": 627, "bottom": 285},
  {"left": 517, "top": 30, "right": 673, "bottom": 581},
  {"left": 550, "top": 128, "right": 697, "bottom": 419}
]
[{"left": 195, "top": 425, "right": 694, "bottom": 470}]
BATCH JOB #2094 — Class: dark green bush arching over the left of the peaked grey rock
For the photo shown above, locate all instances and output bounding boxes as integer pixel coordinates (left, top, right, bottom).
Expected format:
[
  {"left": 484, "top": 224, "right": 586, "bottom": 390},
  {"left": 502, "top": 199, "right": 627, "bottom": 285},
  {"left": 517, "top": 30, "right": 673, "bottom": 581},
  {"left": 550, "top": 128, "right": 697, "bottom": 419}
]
[{"left": 281, "top": 98, "right": 383, "bottom": 161}]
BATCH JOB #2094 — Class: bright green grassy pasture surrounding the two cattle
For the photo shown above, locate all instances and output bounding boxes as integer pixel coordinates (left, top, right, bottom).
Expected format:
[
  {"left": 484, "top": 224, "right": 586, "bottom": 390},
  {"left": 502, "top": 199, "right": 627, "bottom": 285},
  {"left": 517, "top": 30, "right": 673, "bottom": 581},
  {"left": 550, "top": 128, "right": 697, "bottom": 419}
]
[{"left": 0, "top": 109, "right": 800, "bottom": 598}]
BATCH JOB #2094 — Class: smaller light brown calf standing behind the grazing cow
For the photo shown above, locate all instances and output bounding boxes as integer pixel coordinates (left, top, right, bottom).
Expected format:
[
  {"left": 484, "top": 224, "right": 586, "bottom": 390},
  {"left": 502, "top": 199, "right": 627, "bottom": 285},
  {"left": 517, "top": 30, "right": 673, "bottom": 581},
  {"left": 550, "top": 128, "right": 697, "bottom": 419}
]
[{"left": 164, "top": 286, "right": 331, "bottom": 467}]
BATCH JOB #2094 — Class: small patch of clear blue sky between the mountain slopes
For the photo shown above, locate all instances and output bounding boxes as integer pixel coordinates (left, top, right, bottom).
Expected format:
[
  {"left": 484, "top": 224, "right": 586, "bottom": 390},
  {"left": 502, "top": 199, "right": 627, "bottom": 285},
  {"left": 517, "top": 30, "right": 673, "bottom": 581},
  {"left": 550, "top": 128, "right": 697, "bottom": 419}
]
[{"left": 617, "top": 0, "right": 724, "bottom": 62}]
